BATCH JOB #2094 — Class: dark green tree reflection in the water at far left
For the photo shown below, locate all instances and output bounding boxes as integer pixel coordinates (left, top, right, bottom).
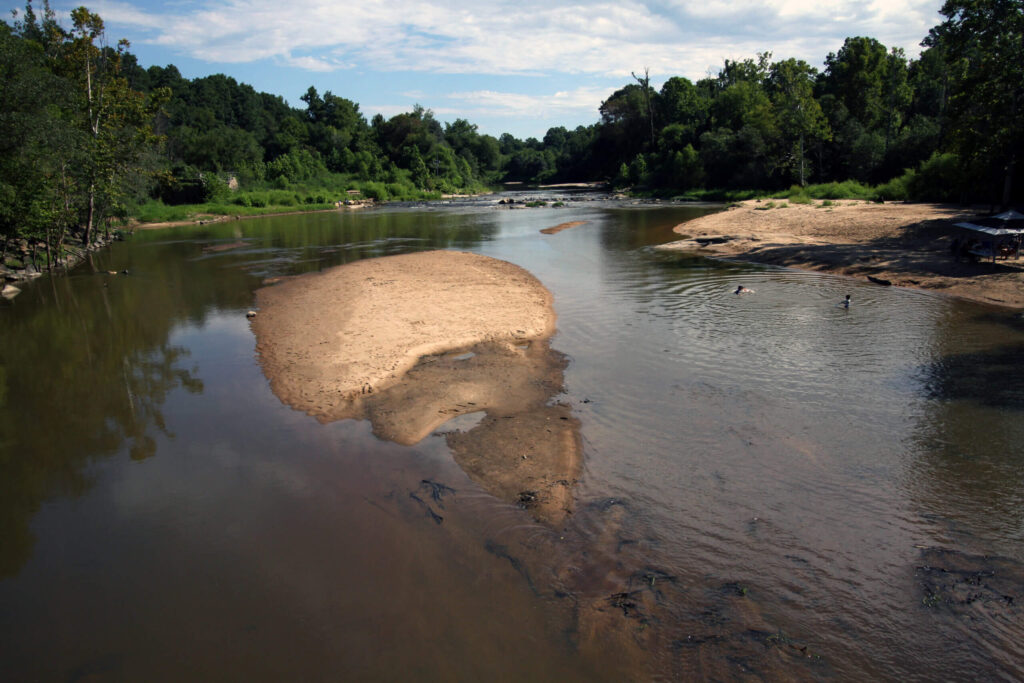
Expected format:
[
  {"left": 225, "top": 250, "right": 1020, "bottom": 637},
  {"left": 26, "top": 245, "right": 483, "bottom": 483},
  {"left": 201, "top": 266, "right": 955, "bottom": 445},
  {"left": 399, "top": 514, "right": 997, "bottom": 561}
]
[{"left": 0, "top": 273, "right": 203, "bottom": 577}]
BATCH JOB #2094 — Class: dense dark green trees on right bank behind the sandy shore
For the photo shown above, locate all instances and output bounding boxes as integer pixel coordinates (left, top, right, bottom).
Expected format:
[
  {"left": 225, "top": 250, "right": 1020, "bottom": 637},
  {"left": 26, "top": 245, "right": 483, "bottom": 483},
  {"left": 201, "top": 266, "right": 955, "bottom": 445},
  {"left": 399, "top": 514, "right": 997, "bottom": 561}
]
[{"left": 524, "top": 0, "right": 1024, "bottom": 205}]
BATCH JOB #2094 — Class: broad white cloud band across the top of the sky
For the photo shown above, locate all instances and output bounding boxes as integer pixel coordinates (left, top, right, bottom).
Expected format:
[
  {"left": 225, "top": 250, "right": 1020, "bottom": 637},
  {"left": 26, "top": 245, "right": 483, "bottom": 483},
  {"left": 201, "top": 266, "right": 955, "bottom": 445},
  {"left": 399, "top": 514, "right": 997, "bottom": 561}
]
[{"left": 95, "top": 0, "right": 941, "bottom": 79}]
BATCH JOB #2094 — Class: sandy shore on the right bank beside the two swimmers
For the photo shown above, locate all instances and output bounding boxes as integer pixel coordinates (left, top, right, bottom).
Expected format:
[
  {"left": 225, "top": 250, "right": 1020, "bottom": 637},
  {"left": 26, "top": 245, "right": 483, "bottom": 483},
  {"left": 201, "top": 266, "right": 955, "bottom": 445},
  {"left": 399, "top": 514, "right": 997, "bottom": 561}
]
[{"left": 662, "top": 200, "right": 1024, "bottom": 308}]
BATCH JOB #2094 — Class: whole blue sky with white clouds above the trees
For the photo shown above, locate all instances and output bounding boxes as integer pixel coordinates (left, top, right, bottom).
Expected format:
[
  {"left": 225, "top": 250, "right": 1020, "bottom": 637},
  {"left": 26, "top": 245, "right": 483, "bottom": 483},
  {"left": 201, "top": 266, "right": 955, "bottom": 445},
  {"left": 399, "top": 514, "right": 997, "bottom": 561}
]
[{"left": 8, "top": 0, "right": 942, "bottom": 138}]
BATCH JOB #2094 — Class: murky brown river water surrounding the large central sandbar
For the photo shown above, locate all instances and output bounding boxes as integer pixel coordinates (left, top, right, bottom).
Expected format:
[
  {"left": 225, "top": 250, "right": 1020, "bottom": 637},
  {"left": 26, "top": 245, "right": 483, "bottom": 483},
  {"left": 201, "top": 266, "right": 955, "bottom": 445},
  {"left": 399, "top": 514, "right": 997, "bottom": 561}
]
[{"left": 0, "top": 194, "right": 1024, "bottom": 681}]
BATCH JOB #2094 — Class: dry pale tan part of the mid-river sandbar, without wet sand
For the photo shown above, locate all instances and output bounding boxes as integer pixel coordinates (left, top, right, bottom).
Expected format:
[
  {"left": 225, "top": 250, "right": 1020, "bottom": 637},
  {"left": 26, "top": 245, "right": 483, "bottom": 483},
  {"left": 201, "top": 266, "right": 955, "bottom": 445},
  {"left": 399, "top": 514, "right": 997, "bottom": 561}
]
[{"left": 253, "top": 251, "right": 555, "bottom": 413}]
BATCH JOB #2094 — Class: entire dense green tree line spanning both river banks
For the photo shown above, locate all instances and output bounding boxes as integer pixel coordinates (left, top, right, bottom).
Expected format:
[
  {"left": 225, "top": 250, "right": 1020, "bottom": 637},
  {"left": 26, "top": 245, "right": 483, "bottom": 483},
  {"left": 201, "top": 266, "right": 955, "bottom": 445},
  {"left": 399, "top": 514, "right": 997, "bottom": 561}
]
[{"left": 0, "top": 0, "right": 1024, "bottom": 270}]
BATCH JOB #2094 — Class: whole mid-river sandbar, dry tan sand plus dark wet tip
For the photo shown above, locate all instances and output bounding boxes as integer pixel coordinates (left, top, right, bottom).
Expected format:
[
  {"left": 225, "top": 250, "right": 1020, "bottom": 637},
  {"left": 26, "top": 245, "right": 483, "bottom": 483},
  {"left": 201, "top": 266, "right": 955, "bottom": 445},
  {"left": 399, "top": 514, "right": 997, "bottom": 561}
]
[{"left": 252, "top": 251, "right": 581, "bottom": 523}]
